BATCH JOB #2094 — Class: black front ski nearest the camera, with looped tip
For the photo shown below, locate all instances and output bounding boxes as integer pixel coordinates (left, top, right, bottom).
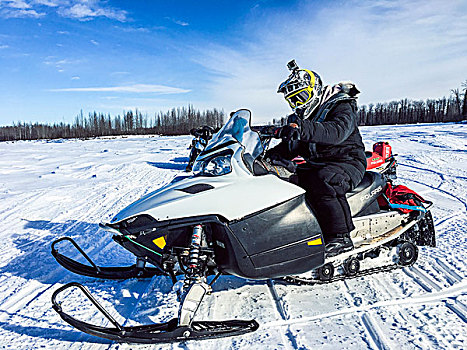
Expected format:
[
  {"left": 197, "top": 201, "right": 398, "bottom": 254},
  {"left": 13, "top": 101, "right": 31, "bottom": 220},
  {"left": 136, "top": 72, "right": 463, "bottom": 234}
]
[{"left": 52, "top": 282, "right": 259, "bottom": 344}]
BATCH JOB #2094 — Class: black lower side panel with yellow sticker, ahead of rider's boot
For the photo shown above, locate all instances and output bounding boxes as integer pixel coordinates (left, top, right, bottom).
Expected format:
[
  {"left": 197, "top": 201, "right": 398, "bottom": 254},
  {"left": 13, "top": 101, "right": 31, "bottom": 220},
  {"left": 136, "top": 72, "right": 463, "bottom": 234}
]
[{"left": 215, "top": 195, "right": 324, "bottom": 279}]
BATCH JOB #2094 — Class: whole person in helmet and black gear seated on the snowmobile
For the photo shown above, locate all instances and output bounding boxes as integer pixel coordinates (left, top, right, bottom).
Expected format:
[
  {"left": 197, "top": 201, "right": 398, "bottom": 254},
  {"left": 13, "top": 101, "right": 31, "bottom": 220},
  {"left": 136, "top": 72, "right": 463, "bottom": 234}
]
[{"left": 267, "top": 60, "right": 366, "bottom": 256}]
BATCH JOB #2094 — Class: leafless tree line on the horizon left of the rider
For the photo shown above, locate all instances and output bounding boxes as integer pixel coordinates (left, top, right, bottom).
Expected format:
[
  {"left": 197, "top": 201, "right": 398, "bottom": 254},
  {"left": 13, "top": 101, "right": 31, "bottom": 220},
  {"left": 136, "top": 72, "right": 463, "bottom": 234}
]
[{"left": 0, "top": 105, "right": 225, "bottom": 141}]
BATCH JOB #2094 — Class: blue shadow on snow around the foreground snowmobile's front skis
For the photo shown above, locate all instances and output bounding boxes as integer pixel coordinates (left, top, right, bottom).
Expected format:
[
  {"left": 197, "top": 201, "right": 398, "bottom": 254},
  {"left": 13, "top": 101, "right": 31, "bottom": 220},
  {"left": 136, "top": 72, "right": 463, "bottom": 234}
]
[{"left": 0, "top": 220, "right": 264, "bottom": 344}]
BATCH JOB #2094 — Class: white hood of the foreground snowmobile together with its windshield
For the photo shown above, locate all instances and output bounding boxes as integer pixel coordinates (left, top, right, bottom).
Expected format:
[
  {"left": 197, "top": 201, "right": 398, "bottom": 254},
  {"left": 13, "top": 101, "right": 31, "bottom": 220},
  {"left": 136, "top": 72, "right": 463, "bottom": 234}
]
[{"left": 111, "top": 109, "right": 305, "bottom": 224}]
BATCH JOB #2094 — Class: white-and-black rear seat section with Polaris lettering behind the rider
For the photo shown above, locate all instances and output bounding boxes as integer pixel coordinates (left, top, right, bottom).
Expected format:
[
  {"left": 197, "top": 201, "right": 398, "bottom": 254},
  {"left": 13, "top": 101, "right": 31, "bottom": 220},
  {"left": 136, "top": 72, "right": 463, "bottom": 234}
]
[{"left": 346, "top": 171, "right": 386, "bottom": 216}]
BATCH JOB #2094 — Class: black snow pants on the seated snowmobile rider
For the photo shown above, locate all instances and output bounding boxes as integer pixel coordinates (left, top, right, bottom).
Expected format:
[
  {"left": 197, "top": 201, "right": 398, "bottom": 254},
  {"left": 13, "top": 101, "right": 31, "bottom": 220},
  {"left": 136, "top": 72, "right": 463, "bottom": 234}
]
[{"left": 297, "top": 161, "right": 365, "bottom": 241}]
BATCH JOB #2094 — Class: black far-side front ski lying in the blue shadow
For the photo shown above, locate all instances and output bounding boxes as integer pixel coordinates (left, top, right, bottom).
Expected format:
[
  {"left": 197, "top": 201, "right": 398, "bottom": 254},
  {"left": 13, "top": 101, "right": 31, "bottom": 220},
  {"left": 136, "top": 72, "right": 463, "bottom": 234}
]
[{"left": 52, "top": 237, "right": 164, "bottom": 279}]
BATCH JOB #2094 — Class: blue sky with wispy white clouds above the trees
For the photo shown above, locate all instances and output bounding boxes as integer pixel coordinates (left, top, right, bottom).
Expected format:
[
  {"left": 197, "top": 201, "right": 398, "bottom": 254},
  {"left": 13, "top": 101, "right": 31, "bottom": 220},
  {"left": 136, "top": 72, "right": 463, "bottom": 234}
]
[{"left": 0, "top": 0, "right": 467, "bottom": 125}]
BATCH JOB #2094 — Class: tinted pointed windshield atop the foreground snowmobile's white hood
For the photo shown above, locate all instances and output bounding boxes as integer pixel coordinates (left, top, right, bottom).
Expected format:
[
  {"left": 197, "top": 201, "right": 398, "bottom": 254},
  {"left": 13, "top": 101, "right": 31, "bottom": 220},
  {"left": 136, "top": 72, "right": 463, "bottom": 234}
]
[{"left": 205, "top": 109, "right": 264, "bottom": 159}]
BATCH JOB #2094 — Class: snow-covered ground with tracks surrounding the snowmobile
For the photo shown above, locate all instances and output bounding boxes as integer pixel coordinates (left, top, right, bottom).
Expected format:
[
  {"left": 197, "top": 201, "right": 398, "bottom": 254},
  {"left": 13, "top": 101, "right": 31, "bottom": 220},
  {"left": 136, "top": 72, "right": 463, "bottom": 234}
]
[{"left": 0, "top": 124, "right": 467, "bottom": 350}]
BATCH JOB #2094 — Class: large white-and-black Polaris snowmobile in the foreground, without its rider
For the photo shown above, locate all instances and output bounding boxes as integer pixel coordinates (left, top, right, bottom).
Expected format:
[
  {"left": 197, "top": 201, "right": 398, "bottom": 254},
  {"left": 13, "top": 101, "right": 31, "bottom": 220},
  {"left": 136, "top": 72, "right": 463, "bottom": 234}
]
[{"left": 52, "top": 109, "right": 435, "bottom": 343}]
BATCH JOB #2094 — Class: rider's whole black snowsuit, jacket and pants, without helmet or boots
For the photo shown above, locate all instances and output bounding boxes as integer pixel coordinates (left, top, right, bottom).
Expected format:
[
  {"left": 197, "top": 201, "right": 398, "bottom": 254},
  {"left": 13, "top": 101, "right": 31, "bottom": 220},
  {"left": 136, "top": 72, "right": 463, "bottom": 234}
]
[{"left": 268, "top": 94, "right": 366, "bottom": 241}]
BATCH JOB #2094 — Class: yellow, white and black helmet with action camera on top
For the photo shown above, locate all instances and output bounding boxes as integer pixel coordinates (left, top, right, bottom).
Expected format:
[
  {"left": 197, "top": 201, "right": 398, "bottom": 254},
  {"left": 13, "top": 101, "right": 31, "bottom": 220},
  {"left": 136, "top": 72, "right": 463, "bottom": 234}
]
[{"left": 277, "top": 60, "right": 323, "bottom": 114}]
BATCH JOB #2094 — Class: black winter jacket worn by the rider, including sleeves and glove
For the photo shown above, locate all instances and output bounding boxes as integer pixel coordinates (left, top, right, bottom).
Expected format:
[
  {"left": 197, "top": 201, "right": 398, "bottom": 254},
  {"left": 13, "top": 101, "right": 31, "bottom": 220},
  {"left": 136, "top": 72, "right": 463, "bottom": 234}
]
[{"left": 268, "top": 99, "right": 366, "bottom": 178}]
